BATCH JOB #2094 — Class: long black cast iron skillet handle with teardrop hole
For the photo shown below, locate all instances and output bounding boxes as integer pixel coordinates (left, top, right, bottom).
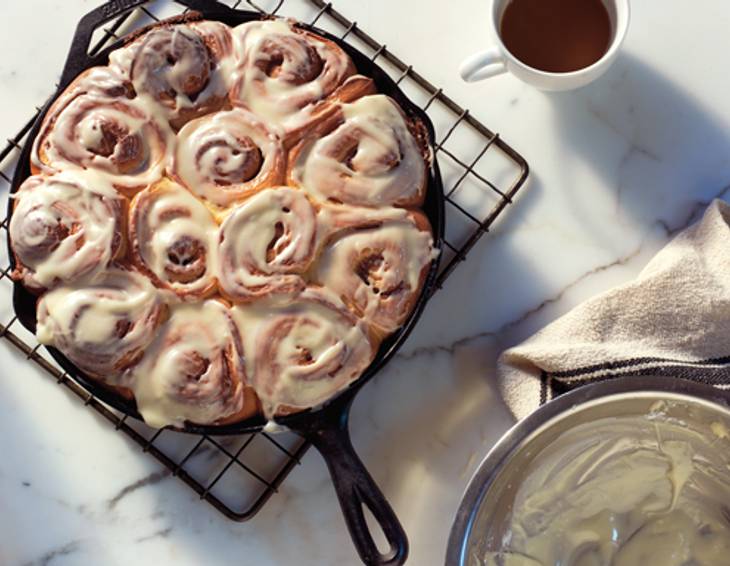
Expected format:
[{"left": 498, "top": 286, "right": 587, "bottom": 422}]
[{"left": 304, "top": 405, "right": 408, "bottom": 566}]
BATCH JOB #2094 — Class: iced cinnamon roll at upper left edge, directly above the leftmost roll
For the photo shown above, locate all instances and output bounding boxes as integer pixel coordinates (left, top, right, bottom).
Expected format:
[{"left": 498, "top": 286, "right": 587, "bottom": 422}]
[{"left": 32, "top": 87, "right": 170, "bottom": 194}]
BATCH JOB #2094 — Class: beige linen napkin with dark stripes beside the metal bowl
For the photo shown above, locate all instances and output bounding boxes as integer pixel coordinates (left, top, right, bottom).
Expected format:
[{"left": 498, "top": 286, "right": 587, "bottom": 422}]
[{"left": 498, "top": 201, "right": 730, "bottom": 417}]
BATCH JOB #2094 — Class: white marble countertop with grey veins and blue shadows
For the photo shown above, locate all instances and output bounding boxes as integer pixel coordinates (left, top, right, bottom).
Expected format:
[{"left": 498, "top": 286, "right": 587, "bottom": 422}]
[{"left": 0, "top": 0, "right": 730, "bottom": 566}]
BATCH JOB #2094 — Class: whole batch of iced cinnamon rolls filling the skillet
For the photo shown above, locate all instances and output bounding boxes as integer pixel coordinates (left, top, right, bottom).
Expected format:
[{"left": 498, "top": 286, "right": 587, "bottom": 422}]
[{"left": 9, "top": 15, "right": 437, "bottom": 427}]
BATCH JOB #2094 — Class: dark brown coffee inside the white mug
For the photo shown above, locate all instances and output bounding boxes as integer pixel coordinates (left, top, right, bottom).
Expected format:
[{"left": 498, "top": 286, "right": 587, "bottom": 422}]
[{"left": 500, "top": 0, "right": 612, "bottom": 73}]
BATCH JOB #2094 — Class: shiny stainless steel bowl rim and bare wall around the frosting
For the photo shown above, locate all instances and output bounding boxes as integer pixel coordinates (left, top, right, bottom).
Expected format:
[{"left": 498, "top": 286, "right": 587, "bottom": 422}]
[{"left": 446, "top": 377, "right": 730, "bottom": 566}]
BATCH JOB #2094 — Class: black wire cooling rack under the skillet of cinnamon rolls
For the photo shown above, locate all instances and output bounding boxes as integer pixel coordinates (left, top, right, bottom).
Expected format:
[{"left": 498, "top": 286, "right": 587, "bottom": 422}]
[{"left": 0, "top": 0, "right": 528, "bottom": 521}]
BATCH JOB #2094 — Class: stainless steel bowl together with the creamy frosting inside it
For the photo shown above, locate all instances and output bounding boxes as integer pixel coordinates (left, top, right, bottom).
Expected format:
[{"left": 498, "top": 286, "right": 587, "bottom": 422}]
[{"left": 447, "top": 378, "right": 730, "bottom": 566}]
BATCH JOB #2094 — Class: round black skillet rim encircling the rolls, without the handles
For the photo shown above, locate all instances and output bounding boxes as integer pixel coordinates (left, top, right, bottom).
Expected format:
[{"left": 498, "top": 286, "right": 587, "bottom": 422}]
[{"left": 7, "top": 5, "right": 445, "bottom": 436}]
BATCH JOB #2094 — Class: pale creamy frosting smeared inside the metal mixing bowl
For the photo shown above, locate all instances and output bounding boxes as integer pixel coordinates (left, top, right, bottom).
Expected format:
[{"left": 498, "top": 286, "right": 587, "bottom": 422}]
[{"left": 480, "top": 415, "right": 730, "bottom": 566}]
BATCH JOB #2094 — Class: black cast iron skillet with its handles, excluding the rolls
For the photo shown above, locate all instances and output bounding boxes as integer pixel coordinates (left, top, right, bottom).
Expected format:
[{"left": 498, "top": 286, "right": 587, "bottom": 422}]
[{"left": 8, "top": 0, "right": 444, "bottom": 565}]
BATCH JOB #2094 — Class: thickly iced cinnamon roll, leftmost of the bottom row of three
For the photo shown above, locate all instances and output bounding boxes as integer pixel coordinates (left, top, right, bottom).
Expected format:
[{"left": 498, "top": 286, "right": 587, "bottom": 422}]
[{"left": 36, "top": 267, "right": 167, "bottom": 387}]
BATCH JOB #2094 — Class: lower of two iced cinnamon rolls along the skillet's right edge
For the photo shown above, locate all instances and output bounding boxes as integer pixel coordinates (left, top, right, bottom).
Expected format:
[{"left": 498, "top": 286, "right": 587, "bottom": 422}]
[{"left": 313, "top": 211, "right": 436, "bottom": 335}]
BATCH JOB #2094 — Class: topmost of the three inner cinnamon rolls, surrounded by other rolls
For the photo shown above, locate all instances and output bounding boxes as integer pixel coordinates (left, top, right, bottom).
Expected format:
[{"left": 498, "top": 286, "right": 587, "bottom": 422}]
[{"left": 172, "top": 108, "right": 286, "bottom": 206}]
